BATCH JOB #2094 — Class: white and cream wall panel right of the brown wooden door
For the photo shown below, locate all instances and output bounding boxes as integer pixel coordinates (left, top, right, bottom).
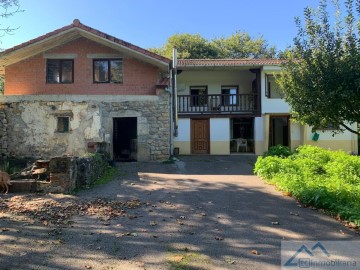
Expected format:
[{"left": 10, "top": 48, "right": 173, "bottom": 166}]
[{"left": 210, "top": 118, "right": 230, "bottom": 155}]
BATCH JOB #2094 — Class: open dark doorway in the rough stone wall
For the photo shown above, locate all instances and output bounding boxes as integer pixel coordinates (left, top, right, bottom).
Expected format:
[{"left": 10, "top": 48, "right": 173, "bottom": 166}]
[{"left": 113, "top": 117, "right": 137, "bottom": 161}]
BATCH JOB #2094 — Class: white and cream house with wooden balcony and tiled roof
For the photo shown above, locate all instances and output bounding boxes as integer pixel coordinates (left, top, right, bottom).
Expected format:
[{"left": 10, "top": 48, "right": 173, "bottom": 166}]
[{"left": 174, "top": 59, "right": 358, "bottom": 155}]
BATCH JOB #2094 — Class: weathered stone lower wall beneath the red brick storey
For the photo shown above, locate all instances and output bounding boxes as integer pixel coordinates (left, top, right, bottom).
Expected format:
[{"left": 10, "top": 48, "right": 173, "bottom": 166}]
[{"left": 0, "top": 91, "right": 170, "bottom": 161}]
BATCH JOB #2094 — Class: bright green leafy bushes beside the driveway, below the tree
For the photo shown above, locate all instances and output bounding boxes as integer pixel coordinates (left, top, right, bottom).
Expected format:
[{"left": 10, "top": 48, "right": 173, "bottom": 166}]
[{"left": 254, "top": 145, "right": 360, "bottom": 225}]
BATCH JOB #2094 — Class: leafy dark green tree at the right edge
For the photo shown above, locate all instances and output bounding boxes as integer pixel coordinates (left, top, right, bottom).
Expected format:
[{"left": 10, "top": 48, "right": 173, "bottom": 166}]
[{"left": 277, "top": 0, "right": 360, "bottom": 135}]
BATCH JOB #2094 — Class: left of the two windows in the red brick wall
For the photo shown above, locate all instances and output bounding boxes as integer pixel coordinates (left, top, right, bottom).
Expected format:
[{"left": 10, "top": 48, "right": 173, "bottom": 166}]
[{"left": 46, "top": 59, "right": 74, "bottom": 83}]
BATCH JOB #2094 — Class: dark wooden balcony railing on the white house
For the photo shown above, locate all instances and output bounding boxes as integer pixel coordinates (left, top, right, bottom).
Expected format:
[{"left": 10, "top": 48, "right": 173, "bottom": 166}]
[{"left": 177, "top": 94, "right": 258, "bottom": 116}]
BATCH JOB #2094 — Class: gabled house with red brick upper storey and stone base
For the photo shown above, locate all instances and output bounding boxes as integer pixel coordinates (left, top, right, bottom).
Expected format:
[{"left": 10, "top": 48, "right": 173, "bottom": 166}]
[{"left": 0, "top": 20, "right": 171, "bottom": 161}]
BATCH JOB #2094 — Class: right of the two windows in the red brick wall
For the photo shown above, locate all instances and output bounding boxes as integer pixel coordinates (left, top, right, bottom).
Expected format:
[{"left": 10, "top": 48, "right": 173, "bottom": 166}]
[{"left": 94, "top": 59, "right": 123, "bottom": 83}]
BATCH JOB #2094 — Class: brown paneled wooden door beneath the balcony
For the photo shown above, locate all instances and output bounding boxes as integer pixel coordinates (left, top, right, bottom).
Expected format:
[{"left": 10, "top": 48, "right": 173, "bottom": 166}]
[{"left": 191, "top": 119, "right": 210, "bottom": 154}]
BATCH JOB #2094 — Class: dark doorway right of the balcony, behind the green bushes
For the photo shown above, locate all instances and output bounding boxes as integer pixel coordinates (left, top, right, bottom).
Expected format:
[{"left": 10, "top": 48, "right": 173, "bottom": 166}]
[{"left": 269, "top": 116, "right": 290, "bottom": 147}]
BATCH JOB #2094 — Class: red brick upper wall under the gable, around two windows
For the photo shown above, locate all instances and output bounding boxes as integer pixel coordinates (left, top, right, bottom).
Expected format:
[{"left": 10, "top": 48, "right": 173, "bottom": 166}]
[{"left": 5, "top": 38, "right": 159, "bottom": 95}]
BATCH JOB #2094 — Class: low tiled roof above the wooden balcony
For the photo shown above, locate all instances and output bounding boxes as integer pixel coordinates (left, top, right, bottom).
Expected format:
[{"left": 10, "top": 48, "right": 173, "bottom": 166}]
[{"left": 177, "top": 59, "right": 284, "bottom": 69}]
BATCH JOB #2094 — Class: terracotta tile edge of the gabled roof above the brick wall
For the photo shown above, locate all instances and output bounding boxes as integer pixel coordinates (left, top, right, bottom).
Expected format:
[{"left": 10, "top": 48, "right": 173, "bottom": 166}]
[{"left": 1, "top": 19, "right": 171, "bottom": 63}]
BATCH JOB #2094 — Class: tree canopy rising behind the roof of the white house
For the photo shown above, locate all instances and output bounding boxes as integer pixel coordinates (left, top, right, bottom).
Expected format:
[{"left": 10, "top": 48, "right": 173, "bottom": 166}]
[{"left": 150, "top": 31, "right": 276, "bottom": 59}]
